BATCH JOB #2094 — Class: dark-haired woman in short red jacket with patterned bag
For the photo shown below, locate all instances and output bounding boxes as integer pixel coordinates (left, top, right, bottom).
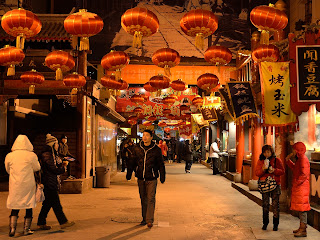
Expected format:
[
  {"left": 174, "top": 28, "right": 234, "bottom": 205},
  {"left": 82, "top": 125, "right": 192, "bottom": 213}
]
[{"left": 255, "top": 145, "right": 284, "bottom": 231}]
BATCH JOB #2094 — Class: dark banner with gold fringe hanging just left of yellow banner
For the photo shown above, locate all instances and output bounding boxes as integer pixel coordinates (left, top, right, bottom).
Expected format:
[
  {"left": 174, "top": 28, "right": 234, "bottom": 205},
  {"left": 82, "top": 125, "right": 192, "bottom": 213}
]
[{"left": 227, "top": 82, "right": 258, "bottom": 123}]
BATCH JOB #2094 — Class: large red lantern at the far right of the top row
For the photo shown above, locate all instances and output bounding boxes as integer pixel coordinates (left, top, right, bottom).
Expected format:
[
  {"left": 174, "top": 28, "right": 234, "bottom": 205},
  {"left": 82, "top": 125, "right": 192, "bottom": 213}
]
[{"left": 250, "top": 5, "right": 288, "bottom": 44}]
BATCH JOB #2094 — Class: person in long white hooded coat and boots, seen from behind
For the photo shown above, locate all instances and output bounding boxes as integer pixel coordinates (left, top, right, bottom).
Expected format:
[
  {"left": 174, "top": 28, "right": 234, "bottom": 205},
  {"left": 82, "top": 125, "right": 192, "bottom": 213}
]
[{"left": 5, "top": 135, "right": 40, "bottom": 237}]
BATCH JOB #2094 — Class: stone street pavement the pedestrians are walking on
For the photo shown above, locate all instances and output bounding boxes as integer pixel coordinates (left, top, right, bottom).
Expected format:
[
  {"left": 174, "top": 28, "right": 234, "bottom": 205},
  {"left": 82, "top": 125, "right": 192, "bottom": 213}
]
[{"left": 0, "top": 163, "right": 320, "bottom": 240}]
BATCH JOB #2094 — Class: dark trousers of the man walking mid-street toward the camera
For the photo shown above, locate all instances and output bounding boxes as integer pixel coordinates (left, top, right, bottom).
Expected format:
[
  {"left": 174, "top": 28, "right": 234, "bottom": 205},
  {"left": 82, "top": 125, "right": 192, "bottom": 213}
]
[{"left": 138, "top": 179, "right": 157, "bottom": 223}]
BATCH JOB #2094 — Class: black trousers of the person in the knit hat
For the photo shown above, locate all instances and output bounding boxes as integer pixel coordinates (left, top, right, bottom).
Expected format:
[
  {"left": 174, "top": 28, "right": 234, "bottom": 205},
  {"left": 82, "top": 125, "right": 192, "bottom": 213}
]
[{"left": 37, "top": 188, "right": 68, "bottom": 225}]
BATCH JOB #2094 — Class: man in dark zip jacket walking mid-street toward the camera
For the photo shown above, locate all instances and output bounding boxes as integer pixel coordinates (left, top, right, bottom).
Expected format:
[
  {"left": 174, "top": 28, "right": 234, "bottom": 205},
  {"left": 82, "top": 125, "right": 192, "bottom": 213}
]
[{"left": 127, "top": 130, "right": 166, "bottom": 228}]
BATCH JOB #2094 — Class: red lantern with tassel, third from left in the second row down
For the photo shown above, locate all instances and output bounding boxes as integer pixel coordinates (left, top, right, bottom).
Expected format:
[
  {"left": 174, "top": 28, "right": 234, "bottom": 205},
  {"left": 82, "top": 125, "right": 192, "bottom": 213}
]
[{"left": 101, "top": 51, "right": 130, "bottom": 80}]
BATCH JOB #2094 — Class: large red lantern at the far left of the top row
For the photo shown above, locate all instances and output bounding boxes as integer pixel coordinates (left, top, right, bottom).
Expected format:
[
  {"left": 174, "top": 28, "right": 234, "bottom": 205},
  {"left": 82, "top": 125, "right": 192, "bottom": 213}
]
[{"left": 1, "top": 8, "right": 42, "bottom": 49}]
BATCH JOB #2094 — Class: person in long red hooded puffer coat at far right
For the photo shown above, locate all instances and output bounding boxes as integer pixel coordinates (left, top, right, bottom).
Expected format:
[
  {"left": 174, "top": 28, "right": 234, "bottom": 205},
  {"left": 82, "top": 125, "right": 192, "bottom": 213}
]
[{"left": 286, "top": 142, "right": 311, "bottom": 237}]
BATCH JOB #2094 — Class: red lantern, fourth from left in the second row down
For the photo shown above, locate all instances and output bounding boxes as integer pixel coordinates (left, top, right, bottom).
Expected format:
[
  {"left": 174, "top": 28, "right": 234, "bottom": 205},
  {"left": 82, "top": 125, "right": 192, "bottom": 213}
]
[{"left": 152, "top": 48, "right": 180, "bottom": 76}]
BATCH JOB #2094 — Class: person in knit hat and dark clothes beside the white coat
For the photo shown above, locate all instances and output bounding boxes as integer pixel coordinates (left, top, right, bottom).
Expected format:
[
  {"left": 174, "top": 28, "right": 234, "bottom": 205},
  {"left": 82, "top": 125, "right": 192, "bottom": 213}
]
[{"left": 37, "top": 134, "right": 74, "bottom": 230}]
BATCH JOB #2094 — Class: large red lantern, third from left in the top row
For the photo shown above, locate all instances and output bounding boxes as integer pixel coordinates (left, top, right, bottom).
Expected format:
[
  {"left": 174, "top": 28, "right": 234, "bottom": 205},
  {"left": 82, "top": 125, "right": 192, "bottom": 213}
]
[{"left": 121, "top": 7, "right": 159, "bottom": 48}]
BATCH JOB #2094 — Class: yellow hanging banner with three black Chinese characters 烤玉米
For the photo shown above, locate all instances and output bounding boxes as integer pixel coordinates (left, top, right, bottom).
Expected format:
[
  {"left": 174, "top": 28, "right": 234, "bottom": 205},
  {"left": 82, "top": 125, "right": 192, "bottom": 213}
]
[{"left": 260, "top": 62, "right": 297, "bottom": 126}]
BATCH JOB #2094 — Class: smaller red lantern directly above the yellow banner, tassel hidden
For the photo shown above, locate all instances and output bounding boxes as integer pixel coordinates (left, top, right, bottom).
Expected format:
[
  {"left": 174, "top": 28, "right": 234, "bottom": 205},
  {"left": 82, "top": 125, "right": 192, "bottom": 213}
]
[{"left": 252, "top": 44, "right": 280, "bottom": 63}]
